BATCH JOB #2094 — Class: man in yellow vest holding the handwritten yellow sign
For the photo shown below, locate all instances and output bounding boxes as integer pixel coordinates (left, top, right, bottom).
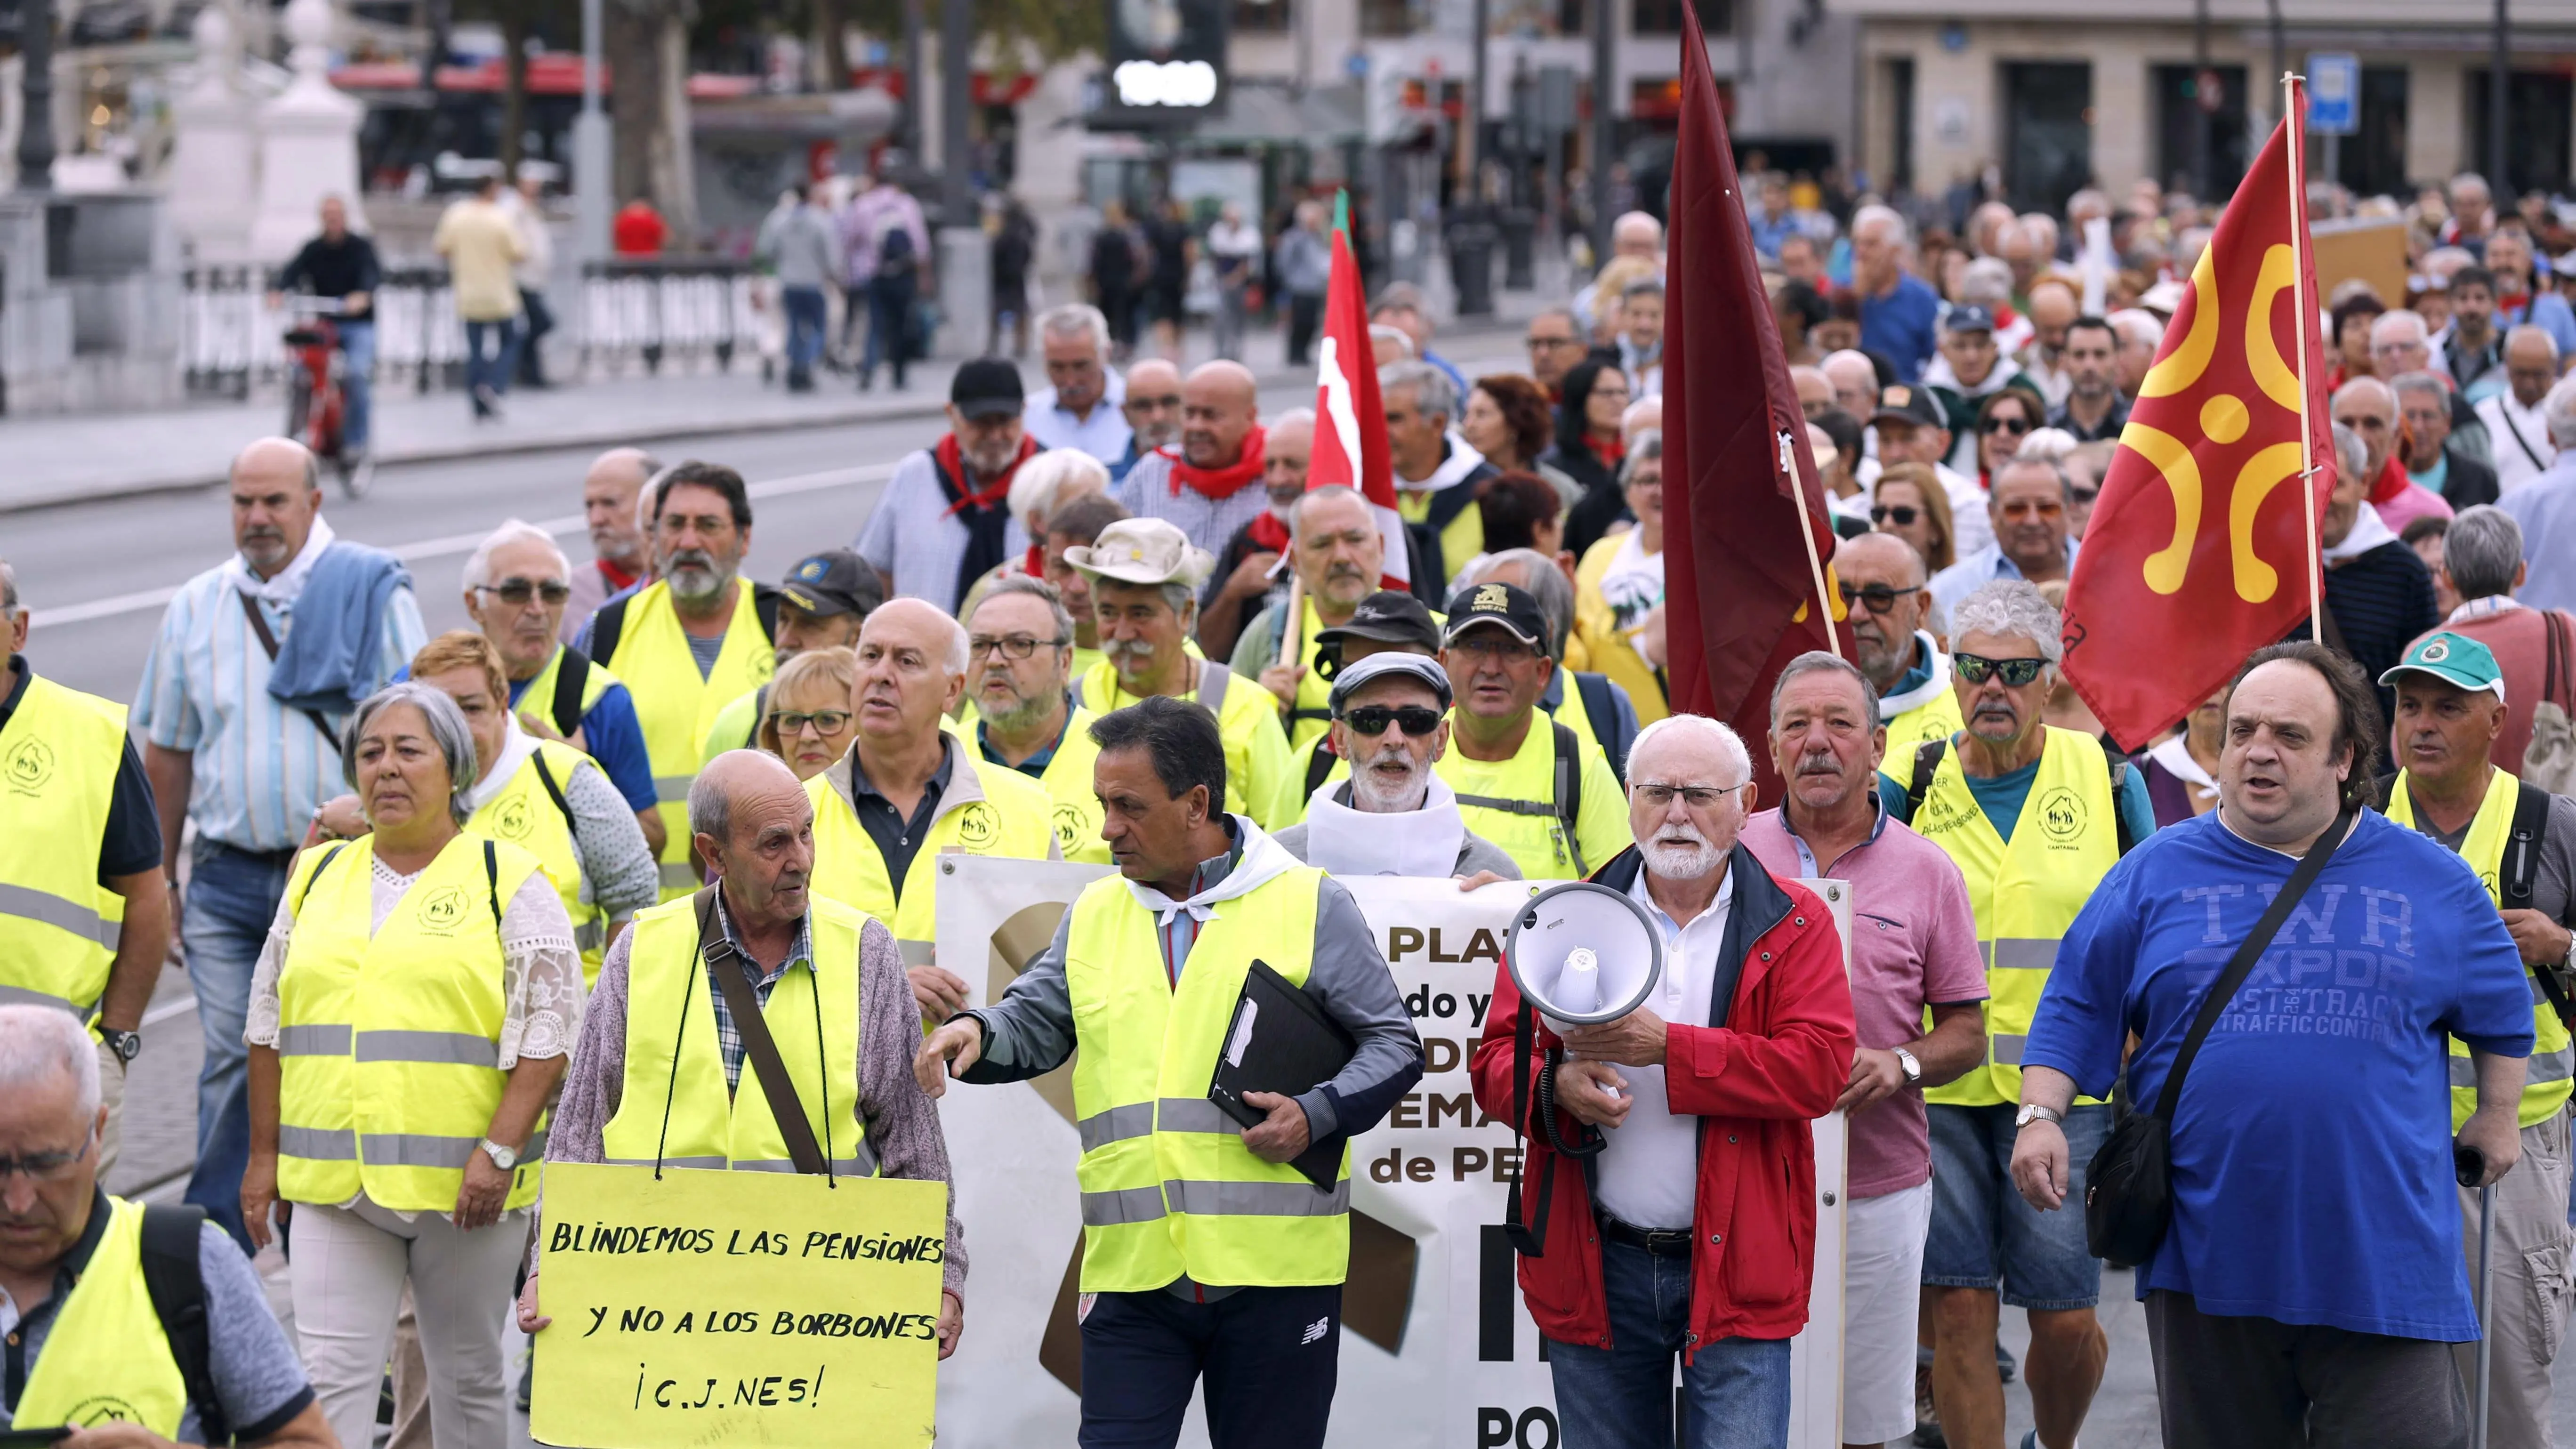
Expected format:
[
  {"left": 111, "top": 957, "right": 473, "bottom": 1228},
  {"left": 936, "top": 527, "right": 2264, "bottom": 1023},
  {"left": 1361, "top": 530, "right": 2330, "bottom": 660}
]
[{"left": 523, "top": 750, "right": 966, "bottom": 1351}]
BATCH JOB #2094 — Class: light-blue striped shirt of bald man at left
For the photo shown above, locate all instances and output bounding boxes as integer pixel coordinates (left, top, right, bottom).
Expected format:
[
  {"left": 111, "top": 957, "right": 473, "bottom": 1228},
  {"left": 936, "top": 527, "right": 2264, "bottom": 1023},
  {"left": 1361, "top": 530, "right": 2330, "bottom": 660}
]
[{"left": 134, "top": 518, "right": 427, "bottom": 851}]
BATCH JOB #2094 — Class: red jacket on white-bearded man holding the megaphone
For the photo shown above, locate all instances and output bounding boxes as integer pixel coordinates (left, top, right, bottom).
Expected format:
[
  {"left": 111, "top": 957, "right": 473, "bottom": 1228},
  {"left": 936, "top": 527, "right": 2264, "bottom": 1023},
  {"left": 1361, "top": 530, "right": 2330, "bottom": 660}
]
[{"left": 1473, "top": 845, "right": 1852, "bottom": 1353}]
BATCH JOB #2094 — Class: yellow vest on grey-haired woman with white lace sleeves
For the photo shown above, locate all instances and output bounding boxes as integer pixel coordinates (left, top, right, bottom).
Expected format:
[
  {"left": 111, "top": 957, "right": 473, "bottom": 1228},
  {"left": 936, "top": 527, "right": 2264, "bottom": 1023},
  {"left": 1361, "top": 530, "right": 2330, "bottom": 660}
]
[{"left": 278, "top": 836, "right": 546, "bottom": 1212}]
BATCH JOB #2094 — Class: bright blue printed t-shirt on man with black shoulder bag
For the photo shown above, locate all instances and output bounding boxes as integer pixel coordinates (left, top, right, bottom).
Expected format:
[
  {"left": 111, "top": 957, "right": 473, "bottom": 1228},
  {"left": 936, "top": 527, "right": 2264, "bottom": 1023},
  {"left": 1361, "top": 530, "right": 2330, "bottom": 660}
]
[{"left": 2022, "top": 812, "right": 2532, "bottom": 1343}]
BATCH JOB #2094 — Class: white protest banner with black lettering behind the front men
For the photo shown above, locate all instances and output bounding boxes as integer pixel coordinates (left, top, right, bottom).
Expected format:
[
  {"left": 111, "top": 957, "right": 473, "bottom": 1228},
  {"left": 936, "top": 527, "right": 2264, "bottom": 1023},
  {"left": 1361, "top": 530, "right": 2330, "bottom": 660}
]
[{"left": 938, "top": 856, "right": 1847, "bottom": 1449}]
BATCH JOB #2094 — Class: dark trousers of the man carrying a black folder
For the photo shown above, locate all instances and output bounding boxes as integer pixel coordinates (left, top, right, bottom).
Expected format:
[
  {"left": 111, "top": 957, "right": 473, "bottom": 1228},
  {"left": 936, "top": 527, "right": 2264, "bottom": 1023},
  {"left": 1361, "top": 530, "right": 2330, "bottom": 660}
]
[{"left": 1082, "top": 1284, "right": 1342, "bottom": 1449}]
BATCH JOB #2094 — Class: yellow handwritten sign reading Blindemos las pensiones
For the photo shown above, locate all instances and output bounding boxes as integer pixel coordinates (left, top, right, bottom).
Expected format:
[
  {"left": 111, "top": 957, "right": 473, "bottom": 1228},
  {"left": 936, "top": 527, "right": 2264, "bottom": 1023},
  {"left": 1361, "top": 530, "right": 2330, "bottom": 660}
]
[{"left": 528, "top": 1163, "right": 948, "bottom": 1449}]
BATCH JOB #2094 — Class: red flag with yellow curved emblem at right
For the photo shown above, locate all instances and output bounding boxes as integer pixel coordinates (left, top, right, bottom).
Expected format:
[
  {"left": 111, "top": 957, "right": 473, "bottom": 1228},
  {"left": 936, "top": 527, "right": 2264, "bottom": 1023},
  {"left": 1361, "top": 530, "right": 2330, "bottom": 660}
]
[{"left": 2066, "top": 88, "right": 2334, "bottom": 750}]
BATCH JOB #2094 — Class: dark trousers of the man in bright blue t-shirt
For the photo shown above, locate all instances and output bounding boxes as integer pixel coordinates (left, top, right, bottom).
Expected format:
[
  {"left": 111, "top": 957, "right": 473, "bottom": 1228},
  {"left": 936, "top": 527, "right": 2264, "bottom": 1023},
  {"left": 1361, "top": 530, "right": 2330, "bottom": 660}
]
[{"left": 2146, "top": 1289, "right": 2468, "bottom": 1449}]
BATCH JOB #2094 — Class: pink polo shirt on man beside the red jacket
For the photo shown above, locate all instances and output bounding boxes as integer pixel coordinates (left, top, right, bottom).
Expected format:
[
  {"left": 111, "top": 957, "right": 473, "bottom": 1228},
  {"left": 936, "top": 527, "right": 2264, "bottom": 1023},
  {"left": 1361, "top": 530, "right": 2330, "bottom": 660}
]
[{"left": 1741, "top": 810, "right": 1986, "bottom": 1196}]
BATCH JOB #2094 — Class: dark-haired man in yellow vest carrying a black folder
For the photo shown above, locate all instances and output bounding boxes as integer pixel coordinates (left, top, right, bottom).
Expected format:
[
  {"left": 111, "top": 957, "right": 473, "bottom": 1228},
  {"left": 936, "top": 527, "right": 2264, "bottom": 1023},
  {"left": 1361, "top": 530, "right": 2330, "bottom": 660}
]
[{"left": 915, "top": 696, "right": 1422, "bottom": 1449}]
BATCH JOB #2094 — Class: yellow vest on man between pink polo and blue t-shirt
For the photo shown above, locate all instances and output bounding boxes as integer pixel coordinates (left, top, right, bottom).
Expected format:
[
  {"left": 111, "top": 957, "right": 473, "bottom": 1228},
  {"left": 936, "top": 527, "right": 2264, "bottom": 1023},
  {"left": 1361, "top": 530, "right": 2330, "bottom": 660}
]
[{"left": 1891, "top": 724, "right": 2120, "bottom": 1106}]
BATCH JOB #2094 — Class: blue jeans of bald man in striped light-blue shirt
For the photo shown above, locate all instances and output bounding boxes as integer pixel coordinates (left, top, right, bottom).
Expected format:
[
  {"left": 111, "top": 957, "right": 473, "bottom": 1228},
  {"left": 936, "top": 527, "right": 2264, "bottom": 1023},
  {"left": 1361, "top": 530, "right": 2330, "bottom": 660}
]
[{"left": 178, "top": 838, "right": 286, "bottom": 1253}]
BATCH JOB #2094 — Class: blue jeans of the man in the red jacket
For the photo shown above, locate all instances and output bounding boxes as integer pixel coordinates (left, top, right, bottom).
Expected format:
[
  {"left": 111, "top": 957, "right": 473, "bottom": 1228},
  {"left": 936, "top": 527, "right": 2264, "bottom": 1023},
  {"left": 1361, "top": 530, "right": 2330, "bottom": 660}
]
[{"left": 1548, "top": 1240, "right": 1788, "bottom": 1449}]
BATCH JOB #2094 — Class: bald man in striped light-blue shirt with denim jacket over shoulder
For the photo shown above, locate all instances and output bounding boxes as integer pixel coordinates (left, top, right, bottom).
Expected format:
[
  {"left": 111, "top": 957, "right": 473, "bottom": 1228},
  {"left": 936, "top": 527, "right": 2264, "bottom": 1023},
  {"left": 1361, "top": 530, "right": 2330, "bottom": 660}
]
[{"left": 131, "top": 438, "right": 427, "bottom": 1248}]
